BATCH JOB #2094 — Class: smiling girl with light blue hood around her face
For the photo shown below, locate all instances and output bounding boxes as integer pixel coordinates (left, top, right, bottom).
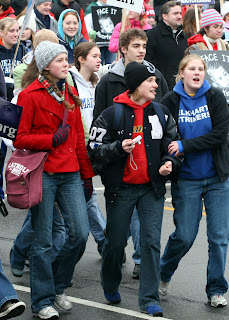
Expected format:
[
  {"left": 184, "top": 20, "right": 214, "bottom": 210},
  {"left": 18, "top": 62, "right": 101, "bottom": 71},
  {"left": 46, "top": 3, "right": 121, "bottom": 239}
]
[{"left": 58, "top": 9, "right": 87, "bottom": 63}]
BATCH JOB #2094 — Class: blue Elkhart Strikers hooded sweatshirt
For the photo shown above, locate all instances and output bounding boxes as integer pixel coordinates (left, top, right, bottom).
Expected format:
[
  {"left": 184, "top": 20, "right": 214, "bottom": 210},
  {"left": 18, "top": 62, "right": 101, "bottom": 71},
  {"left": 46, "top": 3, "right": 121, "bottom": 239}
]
[{"left": 173, "top": 80, "right": 216, "bottom": 180}]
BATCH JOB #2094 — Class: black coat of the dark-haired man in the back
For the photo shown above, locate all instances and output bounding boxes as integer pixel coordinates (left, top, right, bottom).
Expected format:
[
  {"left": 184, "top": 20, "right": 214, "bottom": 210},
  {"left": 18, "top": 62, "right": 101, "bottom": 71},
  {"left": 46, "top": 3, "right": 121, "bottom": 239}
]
[{"left": 145, "top": 21, "right": 188, "bottom": 90}]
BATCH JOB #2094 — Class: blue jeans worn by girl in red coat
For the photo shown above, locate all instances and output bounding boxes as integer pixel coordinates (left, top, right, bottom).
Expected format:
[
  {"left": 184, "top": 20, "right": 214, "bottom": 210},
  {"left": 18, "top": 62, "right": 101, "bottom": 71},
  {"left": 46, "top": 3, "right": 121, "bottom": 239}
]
[{"left": 30, "top": 172, "right": 89, "bottom": 313}]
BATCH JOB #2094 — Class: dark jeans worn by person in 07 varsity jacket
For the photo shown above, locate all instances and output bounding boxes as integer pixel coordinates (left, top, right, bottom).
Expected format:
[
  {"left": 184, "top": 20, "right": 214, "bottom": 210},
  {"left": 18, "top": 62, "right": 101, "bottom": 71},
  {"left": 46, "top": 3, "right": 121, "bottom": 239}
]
[{"left": 101, "top": 184, "right": 164, "bottom": 310}]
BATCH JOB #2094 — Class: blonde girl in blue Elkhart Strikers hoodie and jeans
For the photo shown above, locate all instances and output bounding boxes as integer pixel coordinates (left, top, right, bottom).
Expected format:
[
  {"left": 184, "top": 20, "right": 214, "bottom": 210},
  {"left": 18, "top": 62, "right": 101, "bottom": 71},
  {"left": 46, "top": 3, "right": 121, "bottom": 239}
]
[{"left": 160, "top": 54, "right": 229, "bottom": 307}]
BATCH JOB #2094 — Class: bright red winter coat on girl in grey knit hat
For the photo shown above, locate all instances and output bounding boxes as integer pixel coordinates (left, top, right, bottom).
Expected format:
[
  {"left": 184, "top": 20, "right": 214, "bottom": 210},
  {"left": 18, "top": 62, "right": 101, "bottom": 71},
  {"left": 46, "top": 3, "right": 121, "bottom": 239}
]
[{"left": 14, "top": 80, "right": 94, "bottom": 179}]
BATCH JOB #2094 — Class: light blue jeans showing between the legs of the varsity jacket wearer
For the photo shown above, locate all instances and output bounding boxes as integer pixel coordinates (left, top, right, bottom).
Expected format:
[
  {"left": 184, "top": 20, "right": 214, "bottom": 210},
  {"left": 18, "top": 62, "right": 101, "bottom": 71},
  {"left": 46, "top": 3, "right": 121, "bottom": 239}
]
[{"left": 130, "top": 208, "right": 141, "bottom": 264}]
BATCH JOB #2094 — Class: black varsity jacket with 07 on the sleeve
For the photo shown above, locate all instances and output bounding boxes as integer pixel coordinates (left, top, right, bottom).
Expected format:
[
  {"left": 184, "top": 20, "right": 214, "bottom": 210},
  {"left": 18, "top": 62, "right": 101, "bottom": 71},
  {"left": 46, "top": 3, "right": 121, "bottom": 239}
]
[{"left": 88, "top": 103, "right": 180, "bottom": 198}]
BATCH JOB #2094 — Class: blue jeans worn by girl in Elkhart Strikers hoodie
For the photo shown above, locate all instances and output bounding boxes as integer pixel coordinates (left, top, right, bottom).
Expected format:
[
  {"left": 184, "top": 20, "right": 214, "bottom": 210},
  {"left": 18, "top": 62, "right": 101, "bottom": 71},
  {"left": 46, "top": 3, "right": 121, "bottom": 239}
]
[{"left": 161, "top": 176, "right": 229, "bottom": 298}]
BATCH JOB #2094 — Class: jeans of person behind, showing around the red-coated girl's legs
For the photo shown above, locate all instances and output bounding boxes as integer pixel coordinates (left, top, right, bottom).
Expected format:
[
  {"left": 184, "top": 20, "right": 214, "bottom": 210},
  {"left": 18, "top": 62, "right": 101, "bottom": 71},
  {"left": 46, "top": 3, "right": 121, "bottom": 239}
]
[{"left": 10, "top": 205, "right": 66, "bottom": 270}]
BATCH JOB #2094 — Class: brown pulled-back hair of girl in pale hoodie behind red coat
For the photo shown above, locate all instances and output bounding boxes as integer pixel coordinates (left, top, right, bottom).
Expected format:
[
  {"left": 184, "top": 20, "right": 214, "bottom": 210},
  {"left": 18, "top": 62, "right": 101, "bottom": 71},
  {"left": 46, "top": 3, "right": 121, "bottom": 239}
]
[{"left": 74, "top": 42, "right": 99, "bottom": 86}]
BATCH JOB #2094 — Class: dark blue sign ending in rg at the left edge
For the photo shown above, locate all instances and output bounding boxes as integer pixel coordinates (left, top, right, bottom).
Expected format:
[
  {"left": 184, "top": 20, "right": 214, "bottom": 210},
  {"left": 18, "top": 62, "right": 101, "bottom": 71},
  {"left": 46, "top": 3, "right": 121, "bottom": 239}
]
[{"left": 0, "top": 98, "right": 23, "bottom": 141}]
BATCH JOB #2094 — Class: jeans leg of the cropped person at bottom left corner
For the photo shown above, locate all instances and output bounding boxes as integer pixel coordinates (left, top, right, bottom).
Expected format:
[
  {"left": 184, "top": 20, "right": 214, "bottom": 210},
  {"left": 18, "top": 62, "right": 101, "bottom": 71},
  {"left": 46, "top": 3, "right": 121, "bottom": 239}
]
[{"left": 0, "top": 260, "right": 19, "bottom": 308}]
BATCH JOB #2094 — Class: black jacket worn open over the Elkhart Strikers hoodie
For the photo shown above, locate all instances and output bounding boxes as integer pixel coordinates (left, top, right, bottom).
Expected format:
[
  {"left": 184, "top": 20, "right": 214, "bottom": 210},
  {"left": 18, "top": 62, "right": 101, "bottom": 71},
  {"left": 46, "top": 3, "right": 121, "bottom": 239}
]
[{"left": 161, "top": 88, "right": 229, "bottom": 180}]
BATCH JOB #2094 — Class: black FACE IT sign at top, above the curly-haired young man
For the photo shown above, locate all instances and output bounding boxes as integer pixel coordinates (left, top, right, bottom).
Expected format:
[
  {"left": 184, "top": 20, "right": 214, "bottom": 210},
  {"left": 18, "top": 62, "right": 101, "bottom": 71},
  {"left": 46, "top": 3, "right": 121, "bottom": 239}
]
[{"left": 91, "top": 6, "right": 122, "bottom": 46}]
